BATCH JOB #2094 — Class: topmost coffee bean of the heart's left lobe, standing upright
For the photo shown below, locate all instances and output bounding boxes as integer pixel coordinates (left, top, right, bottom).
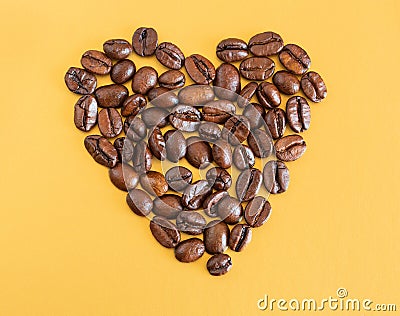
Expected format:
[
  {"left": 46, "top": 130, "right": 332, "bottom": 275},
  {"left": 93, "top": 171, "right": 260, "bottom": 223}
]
[{"left": 132, "top": 27, "right": 158, "bottom": 56}]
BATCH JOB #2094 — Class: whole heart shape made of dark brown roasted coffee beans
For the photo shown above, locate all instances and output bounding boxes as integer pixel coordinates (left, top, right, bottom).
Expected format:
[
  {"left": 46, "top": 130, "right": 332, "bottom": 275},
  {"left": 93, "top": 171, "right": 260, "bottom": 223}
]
[{"left": 65, "top": 27, "right": 327, "bottom": 275}]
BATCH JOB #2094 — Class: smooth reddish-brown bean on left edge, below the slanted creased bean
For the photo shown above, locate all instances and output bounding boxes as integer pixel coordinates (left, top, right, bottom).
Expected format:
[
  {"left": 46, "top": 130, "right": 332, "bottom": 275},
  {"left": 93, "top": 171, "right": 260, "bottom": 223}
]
[{"left": 108, "top": 163, "right": 139, "bottom": 191}]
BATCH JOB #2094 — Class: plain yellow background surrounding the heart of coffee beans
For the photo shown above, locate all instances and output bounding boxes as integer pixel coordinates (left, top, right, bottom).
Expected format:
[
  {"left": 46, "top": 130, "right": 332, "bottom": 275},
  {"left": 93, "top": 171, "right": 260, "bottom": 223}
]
[{"left": 0, "top": 0, "right": 400, "bottom": 316}]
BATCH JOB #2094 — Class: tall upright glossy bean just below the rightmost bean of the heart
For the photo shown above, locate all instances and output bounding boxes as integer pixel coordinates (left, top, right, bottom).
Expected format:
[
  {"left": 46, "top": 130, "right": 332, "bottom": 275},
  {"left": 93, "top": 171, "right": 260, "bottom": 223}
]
[{"left": 286, "top": 96, "right": 311, "bottom": 133}]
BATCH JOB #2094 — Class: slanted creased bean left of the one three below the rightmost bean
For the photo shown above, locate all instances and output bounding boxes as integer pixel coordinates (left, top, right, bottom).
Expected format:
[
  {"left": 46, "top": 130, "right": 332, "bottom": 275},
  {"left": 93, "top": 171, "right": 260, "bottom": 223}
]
[{"left": 236, "top": 168, "right": 262, "bottom": 202}]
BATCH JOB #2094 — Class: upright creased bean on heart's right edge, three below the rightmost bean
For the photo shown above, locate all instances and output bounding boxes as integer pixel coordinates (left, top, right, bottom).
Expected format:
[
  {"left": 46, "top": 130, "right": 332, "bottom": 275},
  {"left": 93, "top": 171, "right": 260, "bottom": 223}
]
[{"left": 263, "top": 160, "right": 290, "bottom": 194}]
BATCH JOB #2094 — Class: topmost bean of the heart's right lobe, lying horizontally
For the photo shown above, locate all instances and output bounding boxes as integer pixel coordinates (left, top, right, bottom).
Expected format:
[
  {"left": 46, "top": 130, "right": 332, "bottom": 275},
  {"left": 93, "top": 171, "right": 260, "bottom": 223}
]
[{"left": 249, "top": 32, "right": 283, "bottom": 57}]
